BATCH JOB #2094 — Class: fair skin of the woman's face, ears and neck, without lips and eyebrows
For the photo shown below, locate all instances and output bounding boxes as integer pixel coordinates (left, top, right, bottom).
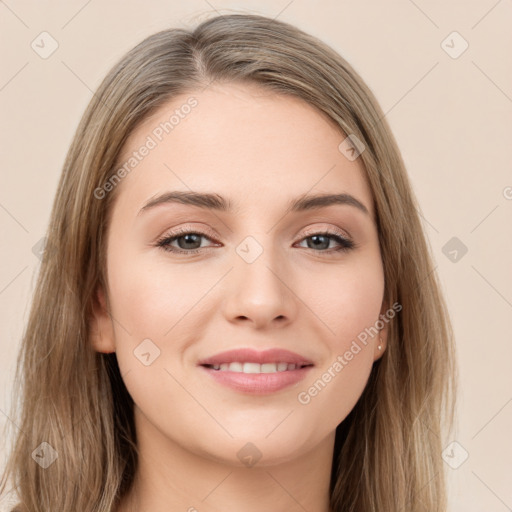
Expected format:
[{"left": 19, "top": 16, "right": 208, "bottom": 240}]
[{"left": 91, "top": 84, "right": 386, "bottom": 512}]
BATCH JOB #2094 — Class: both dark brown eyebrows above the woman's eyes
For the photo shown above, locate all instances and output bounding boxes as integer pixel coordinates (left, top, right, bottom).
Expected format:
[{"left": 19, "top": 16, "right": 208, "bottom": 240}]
[{"left": 139, "top": 191, "right": 370, "bottom": 215}]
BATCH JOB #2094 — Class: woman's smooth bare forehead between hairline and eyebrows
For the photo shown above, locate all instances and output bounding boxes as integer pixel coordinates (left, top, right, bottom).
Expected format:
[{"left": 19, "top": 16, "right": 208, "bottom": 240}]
[{"left": 114, "top": 83, "right": 374, "bottom": 217}]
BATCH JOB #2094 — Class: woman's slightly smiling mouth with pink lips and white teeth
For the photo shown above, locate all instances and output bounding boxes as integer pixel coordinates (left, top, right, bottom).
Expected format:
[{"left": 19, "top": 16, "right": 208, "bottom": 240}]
[{"left": 198, "top": 349, "right": 314, "bottom": 395}]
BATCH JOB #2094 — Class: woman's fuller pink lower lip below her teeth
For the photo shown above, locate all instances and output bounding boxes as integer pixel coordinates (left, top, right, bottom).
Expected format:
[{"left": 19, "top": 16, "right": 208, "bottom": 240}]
[{"left": 200, "top": 366, "right": 313, "bottom": 395}]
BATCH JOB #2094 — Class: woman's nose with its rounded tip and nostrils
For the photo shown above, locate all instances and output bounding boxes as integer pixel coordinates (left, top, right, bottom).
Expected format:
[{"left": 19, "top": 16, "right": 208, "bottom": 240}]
[{"left": 223, "top": 245, "right": 298, "bottom": 329}]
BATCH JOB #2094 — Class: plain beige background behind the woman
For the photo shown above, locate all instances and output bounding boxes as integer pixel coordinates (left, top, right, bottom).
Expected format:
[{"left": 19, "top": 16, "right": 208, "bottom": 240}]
[{"left": 0, "top": 0, "right": 512, "bottom": 512}]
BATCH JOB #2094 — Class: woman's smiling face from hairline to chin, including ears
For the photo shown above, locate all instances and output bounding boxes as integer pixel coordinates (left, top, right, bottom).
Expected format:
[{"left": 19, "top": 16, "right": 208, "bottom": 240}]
[{"left": 92, "top": 84, "right": 385, "bottom": 465}]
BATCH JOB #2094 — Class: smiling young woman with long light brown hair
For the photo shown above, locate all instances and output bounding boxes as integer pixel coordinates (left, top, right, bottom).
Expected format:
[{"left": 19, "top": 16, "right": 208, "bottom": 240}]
[{"left": 0, "top": 15, "right": 455, "bottom": 512}]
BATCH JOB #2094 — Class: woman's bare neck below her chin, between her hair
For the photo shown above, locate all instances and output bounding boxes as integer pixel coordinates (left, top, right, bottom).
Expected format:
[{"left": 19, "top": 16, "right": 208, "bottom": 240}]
[{"left": 117, "top": 407, "right": 335, "bottom": 512}]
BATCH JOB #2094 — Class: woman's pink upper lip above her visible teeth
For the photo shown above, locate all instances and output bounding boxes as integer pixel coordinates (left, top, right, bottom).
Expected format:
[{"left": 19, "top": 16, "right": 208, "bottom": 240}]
[{"left": 198, "top": 348, "right": 313, "bottom": 366}]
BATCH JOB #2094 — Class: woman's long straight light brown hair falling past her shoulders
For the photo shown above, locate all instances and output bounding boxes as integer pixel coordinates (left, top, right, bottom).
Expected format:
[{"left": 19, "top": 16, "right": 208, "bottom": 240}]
[{"left": 2, "top": 14, "right": 456, "bottom": 512}]
